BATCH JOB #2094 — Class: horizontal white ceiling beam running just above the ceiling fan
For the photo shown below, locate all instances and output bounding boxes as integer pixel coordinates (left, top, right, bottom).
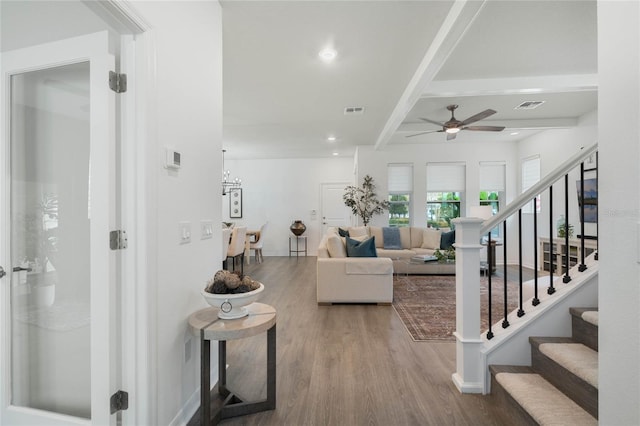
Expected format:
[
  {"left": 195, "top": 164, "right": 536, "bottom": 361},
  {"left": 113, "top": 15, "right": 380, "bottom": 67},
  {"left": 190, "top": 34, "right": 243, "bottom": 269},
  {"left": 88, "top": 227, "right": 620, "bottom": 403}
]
[{"left": 421, "top": 74, "right": 598, "bottom": 98}]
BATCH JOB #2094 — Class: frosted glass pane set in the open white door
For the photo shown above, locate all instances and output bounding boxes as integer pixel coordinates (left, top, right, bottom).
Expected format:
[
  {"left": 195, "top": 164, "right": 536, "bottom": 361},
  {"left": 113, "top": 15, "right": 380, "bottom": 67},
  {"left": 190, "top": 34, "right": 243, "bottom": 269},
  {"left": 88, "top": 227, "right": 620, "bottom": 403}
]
[{"left": 10, "top": 62, "right": 91, "bottom": 418}]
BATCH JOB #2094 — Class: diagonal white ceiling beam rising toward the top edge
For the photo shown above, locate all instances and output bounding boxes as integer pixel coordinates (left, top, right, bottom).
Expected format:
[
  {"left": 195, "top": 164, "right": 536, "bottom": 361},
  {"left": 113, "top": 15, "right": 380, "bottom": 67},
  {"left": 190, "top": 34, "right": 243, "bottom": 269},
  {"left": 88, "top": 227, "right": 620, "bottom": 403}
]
[{"left": 374, "top": 0, "right": 486, "bottom": 150}]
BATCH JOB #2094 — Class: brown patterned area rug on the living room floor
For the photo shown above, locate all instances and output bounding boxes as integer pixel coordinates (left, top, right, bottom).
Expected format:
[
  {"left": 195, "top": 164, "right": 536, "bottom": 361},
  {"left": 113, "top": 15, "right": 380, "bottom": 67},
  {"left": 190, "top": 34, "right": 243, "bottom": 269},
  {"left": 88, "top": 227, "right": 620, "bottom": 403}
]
[{"left": 393, "top": 275, "right": 519, "bottom": 341}]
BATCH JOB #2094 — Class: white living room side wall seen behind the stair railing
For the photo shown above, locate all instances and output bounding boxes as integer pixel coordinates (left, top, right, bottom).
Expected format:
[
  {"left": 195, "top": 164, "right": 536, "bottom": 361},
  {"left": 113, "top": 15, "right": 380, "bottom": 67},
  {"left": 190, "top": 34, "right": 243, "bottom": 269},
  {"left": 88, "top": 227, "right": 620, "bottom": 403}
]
[{"left": 517, "top": 111, "right": 598, "bottom": 267}]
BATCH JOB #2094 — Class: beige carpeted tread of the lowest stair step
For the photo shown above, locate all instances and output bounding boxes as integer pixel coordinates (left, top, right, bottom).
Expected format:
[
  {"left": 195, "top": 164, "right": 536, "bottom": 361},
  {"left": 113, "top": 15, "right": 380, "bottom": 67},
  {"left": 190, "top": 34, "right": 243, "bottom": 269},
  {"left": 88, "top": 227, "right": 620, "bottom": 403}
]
[{"left": 494, "top": 367, "right": 598, "bottom": 425}]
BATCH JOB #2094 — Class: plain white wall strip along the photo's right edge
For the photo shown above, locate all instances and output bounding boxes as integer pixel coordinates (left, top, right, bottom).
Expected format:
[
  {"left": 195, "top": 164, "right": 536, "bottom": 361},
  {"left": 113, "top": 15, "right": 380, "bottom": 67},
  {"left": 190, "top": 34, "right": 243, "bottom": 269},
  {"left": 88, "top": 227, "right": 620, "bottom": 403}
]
[{"left": 598, "top": 1, "right": 640, "bottom": 425}]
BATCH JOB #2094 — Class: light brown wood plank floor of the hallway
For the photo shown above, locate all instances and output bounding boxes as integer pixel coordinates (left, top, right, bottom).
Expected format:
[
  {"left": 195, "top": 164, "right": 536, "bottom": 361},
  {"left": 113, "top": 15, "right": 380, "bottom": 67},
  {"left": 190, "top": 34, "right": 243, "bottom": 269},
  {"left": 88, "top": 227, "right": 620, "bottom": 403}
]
[{"left": 212, "top": 257, "right": 509, "bottom": 426}]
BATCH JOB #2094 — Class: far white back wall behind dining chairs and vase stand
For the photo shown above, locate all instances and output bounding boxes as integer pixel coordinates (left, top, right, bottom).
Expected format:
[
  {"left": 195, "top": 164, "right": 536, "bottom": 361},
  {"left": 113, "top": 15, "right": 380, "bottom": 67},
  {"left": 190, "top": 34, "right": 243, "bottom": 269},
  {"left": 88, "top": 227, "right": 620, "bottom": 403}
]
[{"left": 224, "top": 157, "right": 353, "bottom": 256}]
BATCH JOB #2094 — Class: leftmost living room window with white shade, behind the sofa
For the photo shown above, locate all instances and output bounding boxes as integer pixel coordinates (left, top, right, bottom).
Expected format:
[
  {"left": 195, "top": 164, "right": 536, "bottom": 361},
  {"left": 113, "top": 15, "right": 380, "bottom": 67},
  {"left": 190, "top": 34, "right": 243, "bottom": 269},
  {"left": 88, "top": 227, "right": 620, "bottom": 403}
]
[{"left": 387, "top": 164, "right": 413, "bottom": 227}]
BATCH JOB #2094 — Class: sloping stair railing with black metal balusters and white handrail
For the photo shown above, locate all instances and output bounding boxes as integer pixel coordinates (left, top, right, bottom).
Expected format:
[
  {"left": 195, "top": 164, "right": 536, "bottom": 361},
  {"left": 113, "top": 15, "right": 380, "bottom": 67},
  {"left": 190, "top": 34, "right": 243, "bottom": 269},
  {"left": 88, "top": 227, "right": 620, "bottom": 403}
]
[{"left": 482, "top": 147, "right": 598, "bottom": 339}]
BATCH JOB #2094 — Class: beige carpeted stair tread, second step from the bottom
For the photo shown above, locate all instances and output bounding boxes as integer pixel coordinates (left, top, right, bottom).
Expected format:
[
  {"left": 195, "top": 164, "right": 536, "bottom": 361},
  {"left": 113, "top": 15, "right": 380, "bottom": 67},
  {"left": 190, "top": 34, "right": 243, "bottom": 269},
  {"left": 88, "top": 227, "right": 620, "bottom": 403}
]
[{"left": 529, "top": 337, "right": 598, "bottom": 389}]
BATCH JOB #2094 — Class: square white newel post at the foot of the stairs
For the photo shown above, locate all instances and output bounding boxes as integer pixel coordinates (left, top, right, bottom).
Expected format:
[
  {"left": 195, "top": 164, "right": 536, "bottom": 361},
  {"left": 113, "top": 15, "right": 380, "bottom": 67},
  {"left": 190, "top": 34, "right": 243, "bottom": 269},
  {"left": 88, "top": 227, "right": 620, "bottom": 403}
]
[{"left": 452, "top": 217, "right": 485, "bottom": 393}]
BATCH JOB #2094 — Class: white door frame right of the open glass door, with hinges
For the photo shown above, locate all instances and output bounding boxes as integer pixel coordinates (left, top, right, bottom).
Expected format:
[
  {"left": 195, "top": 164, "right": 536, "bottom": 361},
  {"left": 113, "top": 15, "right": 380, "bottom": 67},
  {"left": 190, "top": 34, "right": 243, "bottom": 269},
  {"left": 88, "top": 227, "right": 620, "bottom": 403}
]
[{"left": 0, "top": 0, "right": 158, "bottom": 425}]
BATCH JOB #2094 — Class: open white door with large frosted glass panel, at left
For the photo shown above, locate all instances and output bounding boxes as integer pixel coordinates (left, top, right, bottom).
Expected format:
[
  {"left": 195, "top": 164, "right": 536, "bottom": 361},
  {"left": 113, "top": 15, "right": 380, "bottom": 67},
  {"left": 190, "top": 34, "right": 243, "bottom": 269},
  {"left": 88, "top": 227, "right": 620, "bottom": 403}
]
[{"left": 0, "top": 32, "right": 117, "bottom": 425}]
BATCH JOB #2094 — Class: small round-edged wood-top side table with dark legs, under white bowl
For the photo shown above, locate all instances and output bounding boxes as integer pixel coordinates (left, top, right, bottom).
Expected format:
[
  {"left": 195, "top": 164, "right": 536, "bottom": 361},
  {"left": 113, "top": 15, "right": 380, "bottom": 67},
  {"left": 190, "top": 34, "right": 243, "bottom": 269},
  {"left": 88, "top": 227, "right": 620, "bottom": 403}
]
[{"left": 189, "top": 303, "right": 276, "bottom": 426}]
